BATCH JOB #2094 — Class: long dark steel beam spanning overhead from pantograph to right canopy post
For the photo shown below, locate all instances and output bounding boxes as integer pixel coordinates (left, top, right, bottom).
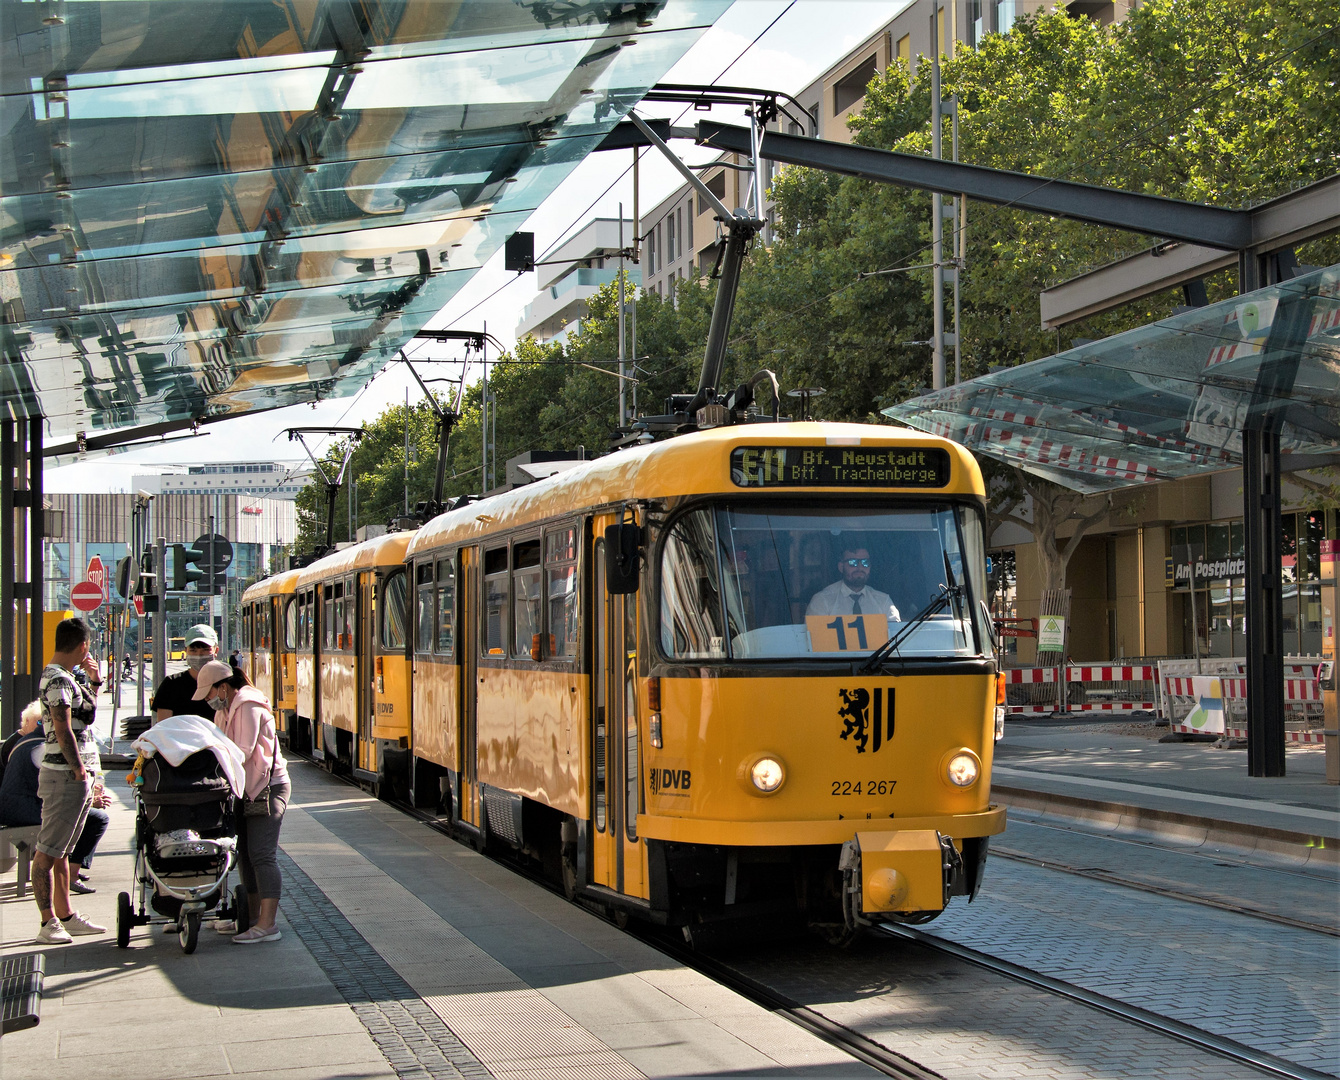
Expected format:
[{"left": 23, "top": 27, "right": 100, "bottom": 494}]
[{"left": 698, "top": 121, "right": 1252, "bottom": 251}]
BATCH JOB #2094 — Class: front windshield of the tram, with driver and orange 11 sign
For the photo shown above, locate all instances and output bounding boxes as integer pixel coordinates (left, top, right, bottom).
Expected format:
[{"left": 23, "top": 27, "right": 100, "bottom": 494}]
[{"left": 661, "top": 504, "right": 990, "bottom": 659}]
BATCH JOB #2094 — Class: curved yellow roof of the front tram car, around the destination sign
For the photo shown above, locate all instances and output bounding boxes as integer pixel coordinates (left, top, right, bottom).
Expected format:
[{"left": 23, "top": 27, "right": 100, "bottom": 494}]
[{"left": 406, "top": 423, "right": 985, "bottom": 557}]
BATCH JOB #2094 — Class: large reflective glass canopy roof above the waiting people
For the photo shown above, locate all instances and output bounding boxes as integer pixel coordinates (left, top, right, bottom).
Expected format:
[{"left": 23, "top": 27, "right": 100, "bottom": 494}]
[{"left": 0, "top": 0, "right": 730, "bottom": 444}]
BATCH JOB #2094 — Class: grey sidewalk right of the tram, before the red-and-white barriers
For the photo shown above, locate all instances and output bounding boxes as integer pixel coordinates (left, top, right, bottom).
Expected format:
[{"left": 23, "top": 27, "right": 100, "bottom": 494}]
[{"left": 992, "top": 718, "right": 1340, "bottom": 864}]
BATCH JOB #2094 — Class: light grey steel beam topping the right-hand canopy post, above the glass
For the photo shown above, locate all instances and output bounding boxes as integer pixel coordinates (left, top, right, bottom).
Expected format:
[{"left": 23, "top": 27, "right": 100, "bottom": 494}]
[{"left": 1039, "top": 173, "right": 1340, "bottom": 330}]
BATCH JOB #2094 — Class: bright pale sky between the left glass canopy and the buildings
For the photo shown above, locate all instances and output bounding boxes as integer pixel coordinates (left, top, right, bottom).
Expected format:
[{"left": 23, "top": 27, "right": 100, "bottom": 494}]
[{"left": 44, "top": 0, "right": 911, "bottom": 493}]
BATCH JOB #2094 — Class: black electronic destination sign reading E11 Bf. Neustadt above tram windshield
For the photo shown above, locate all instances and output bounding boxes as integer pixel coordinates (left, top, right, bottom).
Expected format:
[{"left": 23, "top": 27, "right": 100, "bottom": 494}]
[{"left": 730, "top": 446, "right": 949, "bottom": 488}]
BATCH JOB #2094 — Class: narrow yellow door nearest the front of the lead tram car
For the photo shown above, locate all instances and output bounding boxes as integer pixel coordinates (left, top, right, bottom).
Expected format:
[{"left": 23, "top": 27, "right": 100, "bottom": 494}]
[{"left": 591, "top": 530, "right": 647, "bottom": 896}]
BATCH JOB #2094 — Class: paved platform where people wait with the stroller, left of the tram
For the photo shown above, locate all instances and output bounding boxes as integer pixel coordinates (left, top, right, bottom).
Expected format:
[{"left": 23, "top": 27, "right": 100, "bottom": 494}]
[{"left": 0, "top": 765, "right": 875, "bottom": 1080}]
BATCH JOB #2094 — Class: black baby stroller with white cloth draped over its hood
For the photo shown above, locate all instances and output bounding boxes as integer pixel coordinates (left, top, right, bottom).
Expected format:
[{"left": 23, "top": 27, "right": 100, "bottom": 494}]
[{"left": 117, "top": 734, "right": 248, "bottom": 954}]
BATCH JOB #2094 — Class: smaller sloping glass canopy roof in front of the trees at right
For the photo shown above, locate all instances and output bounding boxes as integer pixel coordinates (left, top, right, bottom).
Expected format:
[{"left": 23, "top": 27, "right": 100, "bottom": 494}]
[{"left": 884, "top": 265, "right": 1340, "bottom": 492}]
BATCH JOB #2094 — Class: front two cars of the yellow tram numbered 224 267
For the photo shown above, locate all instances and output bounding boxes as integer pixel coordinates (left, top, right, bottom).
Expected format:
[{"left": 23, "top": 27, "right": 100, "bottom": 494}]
[{"left": 241, "top": 423, "right": 1005, "bottom": 935}]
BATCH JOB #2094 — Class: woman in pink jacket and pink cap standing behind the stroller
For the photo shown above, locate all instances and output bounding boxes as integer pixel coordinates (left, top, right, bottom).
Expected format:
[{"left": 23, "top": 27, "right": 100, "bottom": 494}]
[{"left": 194, "top": 661, "right": 291, "bottom": 945}]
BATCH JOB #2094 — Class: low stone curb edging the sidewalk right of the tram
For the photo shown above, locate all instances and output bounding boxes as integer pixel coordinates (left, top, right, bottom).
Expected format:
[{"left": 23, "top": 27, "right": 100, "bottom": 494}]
[{"left": 992, "top": 784, "right": 1340, "bottom": 866}]
